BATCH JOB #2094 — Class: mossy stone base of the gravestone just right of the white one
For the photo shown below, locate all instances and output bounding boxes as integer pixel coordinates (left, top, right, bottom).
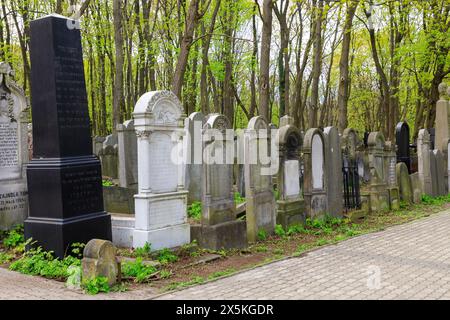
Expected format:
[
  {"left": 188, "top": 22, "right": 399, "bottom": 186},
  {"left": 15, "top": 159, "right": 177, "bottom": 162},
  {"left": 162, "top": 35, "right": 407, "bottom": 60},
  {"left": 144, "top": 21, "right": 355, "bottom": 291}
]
[{"left": 191, "top": 221, "right": 247, "bottom": 250}]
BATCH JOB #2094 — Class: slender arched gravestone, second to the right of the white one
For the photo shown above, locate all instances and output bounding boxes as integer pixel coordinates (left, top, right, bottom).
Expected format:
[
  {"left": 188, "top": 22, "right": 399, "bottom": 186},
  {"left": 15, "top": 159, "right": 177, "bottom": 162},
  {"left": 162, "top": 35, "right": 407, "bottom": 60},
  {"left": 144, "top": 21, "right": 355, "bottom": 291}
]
[{"left": 244, "top": 116, "right": 276, "bottom": 242}]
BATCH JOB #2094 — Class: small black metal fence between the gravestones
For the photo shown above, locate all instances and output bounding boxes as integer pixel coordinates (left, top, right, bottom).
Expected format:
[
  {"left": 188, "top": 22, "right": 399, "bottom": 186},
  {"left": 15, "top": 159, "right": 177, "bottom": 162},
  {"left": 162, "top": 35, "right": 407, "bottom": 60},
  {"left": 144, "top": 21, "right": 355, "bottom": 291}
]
[{"left": 342, "top": 156, "right": 361, "bottom": 212}]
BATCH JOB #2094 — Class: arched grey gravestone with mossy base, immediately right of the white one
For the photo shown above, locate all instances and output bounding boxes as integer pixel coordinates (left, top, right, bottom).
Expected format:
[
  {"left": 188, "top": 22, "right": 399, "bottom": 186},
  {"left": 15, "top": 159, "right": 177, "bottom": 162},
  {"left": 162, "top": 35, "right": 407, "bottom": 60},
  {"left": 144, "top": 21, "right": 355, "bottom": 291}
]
[{"left": 191, "top": 114, "right": 247, "bottom": 250}]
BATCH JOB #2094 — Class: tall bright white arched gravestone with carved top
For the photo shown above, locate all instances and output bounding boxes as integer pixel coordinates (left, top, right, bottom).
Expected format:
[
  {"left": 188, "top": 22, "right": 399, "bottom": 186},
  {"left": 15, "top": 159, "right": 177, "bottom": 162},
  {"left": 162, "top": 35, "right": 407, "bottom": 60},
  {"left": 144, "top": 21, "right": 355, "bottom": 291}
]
[{"left": 133, "top": 91, "right": 190, "bottom": 250}]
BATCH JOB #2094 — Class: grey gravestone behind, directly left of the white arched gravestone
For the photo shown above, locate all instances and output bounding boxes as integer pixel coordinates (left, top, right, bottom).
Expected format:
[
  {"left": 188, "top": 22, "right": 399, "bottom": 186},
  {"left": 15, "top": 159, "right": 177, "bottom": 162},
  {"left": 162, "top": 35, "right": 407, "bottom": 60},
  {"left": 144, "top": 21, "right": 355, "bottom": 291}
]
[{"left": 117, "top": 120, "right": 138, "bottom": 189}]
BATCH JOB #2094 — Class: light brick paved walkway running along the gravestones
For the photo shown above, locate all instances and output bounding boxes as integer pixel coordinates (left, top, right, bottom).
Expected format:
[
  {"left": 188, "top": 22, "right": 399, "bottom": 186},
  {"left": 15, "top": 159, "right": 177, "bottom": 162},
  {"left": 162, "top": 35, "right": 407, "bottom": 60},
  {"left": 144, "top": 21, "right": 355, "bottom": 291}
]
[{"left": 0, "top": 210, "right": 450, "bottom": 300}]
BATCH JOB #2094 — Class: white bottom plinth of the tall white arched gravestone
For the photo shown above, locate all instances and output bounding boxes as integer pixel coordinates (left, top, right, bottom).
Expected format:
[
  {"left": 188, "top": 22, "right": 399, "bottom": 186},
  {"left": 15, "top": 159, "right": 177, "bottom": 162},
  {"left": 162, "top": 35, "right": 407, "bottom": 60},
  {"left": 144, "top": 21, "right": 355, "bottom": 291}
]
[{"left": 133, "top": 223, "right": 190, "bottom": 250}]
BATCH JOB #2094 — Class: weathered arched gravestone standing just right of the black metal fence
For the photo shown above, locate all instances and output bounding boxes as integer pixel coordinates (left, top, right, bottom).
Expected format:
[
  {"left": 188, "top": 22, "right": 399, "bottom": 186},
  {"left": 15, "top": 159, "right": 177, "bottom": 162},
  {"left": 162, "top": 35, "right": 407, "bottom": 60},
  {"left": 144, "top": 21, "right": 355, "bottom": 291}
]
[{"left": 367, "top": 132, "right": 389, "bottom": 211}]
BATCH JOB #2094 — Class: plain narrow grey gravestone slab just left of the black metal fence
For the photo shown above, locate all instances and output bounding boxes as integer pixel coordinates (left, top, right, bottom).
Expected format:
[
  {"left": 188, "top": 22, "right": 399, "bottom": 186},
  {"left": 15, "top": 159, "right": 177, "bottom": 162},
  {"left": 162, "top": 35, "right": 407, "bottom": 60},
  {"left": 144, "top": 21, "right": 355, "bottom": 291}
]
[{"left": 324, "top": 127, "right": 344, "bottom": 217}]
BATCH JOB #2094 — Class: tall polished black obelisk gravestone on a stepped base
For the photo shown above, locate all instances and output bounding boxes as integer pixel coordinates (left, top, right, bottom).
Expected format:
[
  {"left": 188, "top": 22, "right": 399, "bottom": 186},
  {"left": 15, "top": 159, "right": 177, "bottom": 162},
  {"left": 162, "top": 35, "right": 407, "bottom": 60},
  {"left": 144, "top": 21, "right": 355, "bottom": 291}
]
[{"left": 25, "top": 15, "right": 111, "bottom": 257}]
